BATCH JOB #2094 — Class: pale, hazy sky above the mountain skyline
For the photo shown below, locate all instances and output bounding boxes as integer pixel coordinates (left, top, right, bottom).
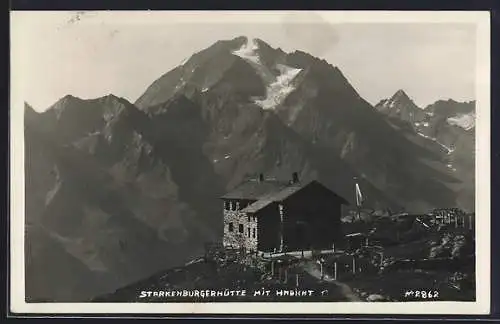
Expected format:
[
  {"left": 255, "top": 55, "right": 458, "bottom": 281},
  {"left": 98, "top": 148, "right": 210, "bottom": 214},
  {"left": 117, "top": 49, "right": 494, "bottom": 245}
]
[{"left": 11, "top": 11, "right": 476, "bottom": 111}]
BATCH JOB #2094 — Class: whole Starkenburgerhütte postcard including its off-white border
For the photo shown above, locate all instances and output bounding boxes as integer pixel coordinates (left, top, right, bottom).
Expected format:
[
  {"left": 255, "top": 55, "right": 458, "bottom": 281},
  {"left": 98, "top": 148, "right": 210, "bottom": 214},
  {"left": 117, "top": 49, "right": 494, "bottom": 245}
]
[{"left": 10, "top": 11, "right": 490, "bottom": 314}]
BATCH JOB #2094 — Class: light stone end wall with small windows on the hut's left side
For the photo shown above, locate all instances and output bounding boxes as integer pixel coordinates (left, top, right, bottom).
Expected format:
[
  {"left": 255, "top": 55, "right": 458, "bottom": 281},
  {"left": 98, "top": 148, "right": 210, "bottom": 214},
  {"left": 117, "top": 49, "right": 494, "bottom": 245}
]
[{"left": 223, "top": 206, "right": 258, "bottom": 252}]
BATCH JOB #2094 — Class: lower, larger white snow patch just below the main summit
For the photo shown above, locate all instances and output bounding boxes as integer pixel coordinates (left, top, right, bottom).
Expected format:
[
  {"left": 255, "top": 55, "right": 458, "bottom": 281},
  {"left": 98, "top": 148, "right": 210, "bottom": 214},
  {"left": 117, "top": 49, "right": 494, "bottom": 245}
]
[{"left": 255, "top": 65, "right": 302, "bottom": 109}]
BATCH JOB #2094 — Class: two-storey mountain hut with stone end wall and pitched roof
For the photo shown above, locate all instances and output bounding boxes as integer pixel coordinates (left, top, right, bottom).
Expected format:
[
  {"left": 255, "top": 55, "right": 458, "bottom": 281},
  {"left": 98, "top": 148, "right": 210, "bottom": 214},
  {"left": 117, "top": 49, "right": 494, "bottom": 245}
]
[{"left": 221, "top": 173, "right": 348, "bottom": 252}]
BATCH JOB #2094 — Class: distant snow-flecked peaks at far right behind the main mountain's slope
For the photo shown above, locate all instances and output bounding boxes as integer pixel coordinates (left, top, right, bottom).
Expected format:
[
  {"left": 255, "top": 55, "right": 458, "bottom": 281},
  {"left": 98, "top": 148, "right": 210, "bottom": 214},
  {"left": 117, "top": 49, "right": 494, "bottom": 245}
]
[{"left": 375, "top": 90, "right": 476, "bottom": 211}]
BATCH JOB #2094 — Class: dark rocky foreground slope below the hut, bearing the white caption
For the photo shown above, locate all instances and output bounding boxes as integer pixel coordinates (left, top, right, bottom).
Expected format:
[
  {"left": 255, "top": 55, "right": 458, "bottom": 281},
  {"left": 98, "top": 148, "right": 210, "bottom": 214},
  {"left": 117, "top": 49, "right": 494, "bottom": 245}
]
[{"left": 93, "top": 220, "right": 475, "bottom": 302}]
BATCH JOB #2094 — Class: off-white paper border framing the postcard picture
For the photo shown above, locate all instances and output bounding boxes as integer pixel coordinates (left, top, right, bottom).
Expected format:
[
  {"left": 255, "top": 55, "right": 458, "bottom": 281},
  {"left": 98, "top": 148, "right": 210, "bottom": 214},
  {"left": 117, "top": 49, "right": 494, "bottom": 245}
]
[{"left": 8, "top": 11, "right": 491, "bottom": 315}]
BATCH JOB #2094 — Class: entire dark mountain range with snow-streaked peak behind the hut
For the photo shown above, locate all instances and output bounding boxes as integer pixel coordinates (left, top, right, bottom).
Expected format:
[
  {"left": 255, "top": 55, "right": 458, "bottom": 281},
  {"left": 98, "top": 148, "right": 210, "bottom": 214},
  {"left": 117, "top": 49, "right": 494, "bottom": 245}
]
[{"left": 25, "top": 37, "right": 474, "bottom": 301}]
